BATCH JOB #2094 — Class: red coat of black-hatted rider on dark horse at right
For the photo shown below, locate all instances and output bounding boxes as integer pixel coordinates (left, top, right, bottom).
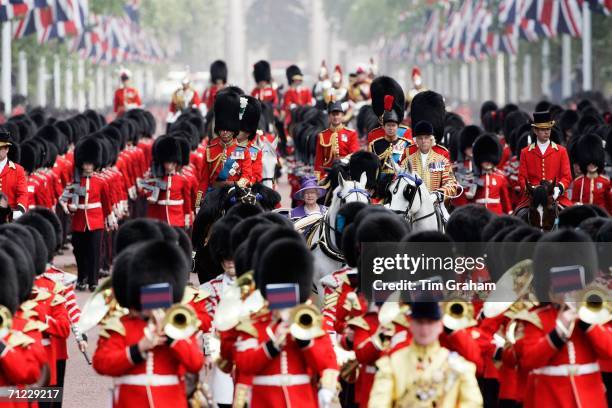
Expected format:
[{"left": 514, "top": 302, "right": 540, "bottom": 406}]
[{"left": 518, "top": 142, "right": 572, "bottom": 207}]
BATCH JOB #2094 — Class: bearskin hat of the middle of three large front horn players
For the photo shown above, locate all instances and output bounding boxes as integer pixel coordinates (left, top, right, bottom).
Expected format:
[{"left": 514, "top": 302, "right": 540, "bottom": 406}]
[{"left": 255, "top": 238, "right": 314, "bottom": 302}]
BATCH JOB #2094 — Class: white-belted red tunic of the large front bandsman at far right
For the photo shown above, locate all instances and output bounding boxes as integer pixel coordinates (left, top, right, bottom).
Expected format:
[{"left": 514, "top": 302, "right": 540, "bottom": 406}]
[{"left": 519, "top": 305, "right": 612, "bottom": 408}]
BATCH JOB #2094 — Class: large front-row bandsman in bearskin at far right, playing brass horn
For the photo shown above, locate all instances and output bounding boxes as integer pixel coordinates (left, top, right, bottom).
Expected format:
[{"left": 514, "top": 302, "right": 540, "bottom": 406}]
[{"left": 517, "top": 228, "right": 612, "bottom": 408}]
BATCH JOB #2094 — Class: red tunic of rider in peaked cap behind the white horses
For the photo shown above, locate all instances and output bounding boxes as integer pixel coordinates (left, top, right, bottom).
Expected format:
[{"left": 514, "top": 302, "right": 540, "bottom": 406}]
[{"left": 314, "top": 126, "right": 360, "bottom": 179}]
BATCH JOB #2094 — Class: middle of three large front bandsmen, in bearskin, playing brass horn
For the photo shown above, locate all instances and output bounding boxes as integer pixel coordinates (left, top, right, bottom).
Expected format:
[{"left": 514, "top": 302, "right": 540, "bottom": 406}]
[{"left": 236, "top": 238, "right": 338, "bottom": 408}]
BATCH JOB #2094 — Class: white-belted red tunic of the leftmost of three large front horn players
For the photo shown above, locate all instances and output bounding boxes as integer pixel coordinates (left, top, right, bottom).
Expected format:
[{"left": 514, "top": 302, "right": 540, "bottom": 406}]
[{"left": 93, "top": 316, "right": 204, "bottom": 408}]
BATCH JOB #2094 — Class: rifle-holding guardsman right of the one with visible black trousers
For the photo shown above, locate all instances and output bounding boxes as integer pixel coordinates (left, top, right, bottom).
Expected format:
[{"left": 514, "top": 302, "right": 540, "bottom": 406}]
[{"left": 143, "top": 136, "right": 191, "bottom": 228}]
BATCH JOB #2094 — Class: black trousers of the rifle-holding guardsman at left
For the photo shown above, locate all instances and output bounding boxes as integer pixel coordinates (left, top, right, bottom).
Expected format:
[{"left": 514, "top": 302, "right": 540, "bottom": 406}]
[{"left": 72, "top": 229, "right": 104, "bottom": 285}]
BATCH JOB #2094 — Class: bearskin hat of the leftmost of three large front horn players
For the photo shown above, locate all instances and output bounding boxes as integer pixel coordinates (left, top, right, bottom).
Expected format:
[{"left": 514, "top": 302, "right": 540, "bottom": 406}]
[{"left": 122, "top": 241, "right": 189, "bottom": 310}]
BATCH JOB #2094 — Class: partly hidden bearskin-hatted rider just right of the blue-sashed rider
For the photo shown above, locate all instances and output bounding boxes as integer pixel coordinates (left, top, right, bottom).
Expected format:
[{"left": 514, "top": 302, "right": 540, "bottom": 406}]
[{"left": 236, "top": 95, "right": 263, "bottom": 184}]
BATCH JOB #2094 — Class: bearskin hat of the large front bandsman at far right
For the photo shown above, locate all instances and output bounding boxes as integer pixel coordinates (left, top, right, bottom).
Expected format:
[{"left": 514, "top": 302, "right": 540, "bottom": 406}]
[{"left": 533, "top": 231, "right": 599, "bottom": 302}]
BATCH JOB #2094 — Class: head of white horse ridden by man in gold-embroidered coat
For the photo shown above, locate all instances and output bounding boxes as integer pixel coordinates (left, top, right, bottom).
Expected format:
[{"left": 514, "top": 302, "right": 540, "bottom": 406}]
[{"left": 385, "top": 163, "right": 444, "bottom": 232}]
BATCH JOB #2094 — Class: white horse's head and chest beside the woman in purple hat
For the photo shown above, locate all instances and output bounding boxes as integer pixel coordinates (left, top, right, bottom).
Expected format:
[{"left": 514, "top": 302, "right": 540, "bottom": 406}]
[{"left": 307, "top": 172, "right": 370, "bottom": 301}]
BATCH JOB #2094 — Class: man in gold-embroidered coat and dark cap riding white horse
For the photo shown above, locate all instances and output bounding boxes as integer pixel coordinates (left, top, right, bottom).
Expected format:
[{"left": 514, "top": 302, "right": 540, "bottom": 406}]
[{"left": 401, "top": 120, "right": 457, "bottom": 208}]
